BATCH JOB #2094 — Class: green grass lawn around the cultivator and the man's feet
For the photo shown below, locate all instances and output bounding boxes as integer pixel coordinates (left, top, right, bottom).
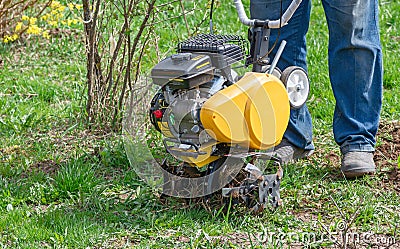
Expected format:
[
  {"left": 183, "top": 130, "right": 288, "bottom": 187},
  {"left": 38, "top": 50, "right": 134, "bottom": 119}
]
[{"left": 0, "top": 1, "right": 400, "bottom": 248}]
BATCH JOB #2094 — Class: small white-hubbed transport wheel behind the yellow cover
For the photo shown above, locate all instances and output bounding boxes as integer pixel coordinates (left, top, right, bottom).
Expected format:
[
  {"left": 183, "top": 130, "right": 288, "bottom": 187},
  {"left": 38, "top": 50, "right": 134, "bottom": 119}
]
[{"left": 281, "top": 66, "right": 310, "bottom": 109}]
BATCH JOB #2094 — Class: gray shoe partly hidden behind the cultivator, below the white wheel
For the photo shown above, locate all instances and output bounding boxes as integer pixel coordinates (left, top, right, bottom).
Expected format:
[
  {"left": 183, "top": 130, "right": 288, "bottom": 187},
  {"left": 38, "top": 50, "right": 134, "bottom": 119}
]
[{"left": 271, "top": 138, "right": 314, "bottom": 164}]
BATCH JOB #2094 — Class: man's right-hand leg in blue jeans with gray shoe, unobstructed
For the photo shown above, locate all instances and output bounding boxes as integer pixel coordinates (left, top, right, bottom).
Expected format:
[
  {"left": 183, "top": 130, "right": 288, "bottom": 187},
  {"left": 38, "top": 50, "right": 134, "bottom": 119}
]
[{"left": 322, "top": 0, "right": 383, "bottom": 177}]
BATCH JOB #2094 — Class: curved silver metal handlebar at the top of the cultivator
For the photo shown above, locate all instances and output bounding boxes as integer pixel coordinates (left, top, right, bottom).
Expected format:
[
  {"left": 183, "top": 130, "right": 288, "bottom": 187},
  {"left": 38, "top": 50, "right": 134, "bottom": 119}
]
[{"left": 233, "top": 0, "right": 302, "bottom": 29}]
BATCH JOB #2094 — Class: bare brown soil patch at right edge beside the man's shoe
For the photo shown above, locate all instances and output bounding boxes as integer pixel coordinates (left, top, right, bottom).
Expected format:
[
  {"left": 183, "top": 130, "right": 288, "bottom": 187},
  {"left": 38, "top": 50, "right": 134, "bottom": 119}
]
[{"left": 374, "top": 121, "right": 400, "bottom": 192}]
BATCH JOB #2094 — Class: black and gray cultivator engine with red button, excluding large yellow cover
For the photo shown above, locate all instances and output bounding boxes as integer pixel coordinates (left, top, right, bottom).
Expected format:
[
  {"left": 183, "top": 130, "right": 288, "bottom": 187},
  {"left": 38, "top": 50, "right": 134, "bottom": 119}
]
[{"left": 150, "top": 34, "right": 245, "bottom": 164}]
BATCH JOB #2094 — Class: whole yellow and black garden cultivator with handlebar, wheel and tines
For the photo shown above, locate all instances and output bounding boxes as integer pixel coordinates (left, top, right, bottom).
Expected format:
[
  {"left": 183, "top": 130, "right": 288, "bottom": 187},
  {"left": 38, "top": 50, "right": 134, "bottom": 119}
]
[{"left": 149, "top": 0, "right": 309, "bottom": 212}]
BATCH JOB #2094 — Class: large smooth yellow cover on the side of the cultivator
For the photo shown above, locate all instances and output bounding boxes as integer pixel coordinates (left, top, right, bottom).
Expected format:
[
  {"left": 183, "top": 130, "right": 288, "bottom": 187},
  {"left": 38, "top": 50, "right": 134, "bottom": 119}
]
[{"left": 200, "top": 72, "right": 290, "bottom": 150}]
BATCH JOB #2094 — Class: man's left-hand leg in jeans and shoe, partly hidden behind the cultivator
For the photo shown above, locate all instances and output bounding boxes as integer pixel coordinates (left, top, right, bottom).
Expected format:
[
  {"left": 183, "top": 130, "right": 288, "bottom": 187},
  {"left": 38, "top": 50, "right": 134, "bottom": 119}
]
[{"left": 250, "top": 0, "right": 314, "bottom": 162}]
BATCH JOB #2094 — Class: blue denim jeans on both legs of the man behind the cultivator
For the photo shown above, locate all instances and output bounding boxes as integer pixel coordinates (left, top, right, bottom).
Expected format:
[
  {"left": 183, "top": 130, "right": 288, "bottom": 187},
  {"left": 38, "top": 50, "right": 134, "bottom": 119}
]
[{"left": 250, "top": 0, "right": 383, "bottom": 153}]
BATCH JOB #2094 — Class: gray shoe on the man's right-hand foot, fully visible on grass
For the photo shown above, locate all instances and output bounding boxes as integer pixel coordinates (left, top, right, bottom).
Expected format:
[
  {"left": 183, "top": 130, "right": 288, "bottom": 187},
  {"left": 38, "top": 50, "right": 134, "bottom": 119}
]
[{"left": 340, "top": 151, "right": 375, "bottom": 178}]
